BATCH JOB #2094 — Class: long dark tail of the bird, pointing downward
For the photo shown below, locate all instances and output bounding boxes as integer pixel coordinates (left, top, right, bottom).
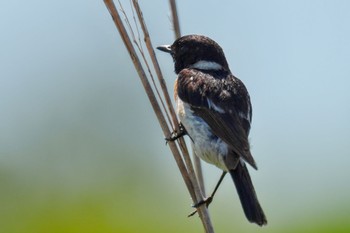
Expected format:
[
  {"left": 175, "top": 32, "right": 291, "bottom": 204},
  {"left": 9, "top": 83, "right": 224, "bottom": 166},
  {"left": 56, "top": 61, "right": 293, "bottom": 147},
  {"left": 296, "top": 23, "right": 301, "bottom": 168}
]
[{"left": 230, "top": 162, "right": 267, "bottom": 226}]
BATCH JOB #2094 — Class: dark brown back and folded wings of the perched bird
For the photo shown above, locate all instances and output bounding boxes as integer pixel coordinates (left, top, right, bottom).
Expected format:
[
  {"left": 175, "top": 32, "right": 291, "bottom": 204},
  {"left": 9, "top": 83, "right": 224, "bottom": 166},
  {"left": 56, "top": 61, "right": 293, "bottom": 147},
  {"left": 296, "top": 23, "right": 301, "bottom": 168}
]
[{"left": 177, "top": 69, "right": 257, "bottom": 169}]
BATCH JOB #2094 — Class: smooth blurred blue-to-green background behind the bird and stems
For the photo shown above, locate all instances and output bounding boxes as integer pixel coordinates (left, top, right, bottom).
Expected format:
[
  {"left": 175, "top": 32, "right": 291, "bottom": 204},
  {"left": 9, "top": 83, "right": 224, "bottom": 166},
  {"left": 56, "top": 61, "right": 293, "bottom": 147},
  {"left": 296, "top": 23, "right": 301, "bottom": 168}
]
[{"left": 0, "top": 0, "right": 350, "bottom": 233}]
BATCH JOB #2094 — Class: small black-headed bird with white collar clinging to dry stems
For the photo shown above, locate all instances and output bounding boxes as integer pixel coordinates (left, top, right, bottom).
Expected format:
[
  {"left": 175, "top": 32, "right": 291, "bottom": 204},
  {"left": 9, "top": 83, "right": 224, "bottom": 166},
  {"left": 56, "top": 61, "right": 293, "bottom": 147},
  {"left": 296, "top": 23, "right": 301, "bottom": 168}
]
[{"left": 157, "top": 35, "right": 267, "bottom": 226}]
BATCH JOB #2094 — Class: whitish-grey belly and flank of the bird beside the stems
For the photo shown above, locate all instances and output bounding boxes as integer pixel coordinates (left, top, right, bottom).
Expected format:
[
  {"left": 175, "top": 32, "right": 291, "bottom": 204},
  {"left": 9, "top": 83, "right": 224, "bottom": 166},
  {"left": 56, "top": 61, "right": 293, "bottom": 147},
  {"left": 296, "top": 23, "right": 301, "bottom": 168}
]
[{"left": 176, "top": 98, "right": 228, "bottom": 171}]
